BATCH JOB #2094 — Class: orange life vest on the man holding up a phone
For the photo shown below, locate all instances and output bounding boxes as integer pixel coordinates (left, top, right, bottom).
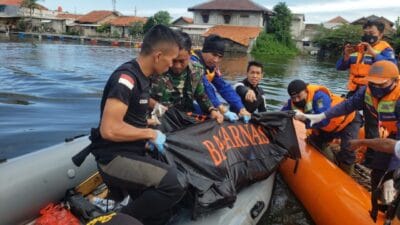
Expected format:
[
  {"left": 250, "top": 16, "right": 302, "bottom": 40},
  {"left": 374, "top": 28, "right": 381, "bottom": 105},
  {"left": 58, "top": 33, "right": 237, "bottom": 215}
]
[{"left": 347, "top": 41, "right": 392, "bottom": 91}]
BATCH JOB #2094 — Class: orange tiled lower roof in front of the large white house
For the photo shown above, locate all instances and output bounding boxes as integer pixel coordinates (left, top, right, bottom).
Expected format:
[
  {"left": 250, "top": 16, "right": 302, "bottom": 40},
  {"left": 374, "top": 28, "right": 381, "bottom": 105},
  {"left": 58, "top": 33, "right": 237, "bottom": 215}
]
[{"left": 203, "top": 25, "right": 262, "bottom": 47}]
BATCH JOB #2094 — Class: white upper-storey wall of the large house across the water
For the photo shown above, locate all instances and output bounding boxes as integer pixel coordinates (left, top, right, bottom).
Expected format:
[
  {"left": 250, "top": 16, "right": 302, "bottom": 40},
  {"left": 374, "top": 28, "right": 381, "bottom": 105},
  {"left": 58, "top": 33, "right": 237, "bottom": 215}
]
[{"left": 193, "top": 11, "right": 265, "bottom": 27}]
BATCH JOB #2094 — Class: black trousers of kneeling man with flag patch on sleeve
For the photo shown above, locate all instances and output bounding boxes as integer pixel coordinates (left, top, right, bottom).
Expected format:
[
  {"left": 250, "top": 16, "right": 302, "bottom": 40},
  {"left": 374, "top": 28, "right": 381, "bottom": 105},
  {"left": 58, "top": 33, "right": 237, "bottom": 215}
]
[{"left": 98, "top": 154, "right": 185, "bottom": 225}]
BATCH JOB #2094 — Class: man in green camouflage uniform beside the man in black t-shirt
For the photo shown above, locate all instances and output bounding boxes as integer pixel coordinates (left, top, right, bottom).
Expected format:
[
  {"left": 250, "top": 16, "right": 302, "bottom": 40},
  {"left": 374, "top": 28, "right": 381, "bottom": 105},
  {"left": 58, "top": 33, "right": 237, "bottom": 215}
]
[{"left": 151, "top": 31, "right": 223, "bottom": 122}]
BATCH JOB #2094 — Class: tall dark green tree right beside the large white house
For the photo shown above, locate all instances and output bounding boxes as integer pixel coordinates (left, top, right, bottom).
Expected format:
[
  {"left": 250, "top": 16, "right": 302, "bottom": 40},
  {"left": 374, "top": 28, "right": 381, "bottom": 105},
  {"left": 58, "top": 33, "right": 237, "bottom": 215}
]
[{"left": 267, "top": 2, "right": 294, "bottom": 46}]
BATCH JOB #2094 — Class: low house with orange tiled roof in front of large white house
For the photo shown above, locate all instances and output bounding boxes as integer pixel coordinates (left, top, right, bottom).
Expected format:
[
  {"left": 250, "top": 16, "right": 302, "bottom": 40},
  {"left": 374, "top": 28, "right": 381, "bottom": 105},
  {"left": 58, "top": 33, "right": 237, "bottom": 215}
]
[{"left": 204, "top": 25, "right": 262, "bottom": 53}]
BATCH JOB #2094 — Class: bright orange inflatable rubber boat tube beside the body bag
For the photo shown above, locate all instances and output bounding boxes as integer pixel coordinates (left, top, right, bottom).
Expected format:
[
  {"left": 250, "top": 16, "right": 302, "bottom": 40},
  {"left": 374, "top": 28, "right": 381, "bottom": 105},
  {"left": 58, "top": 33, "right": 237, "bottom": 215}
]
[{"left": 279, "top": 121, "right": 385, "bottom": 225}]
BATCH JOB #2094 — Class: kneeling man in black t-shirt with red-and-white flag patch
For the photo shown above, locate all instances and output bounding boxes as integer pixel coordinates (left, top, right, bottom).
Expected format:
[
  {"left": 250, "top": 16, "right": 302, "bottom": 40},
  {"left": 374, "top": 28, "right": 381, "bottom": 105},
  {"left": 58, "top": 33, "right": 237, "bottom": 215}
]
[{"left": 90, "top": 25, "right": 185, "bottom": 225}]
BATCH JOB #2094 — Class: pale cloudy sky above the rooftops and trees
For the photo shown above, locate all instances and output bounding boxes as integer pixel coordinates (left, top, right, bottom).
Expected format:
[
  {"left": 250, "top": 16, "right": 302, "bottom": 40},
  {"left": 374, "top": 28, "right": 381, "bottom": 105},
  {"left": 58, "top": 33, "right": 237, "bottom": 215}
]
[{"left": 39, "top": 0, "right": 400, "bottom": 23}]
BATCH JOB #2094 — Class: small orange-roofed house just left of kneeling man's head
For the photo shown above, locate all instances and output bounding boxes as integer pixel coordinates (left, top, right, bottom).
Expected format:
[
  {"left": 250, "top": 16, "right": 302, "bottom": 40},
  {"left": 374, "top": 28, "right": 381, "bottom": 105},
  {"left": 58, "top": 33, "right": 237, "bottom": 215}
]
[{"left": 110, "top": 16, "right": 147, "bottom": 38}]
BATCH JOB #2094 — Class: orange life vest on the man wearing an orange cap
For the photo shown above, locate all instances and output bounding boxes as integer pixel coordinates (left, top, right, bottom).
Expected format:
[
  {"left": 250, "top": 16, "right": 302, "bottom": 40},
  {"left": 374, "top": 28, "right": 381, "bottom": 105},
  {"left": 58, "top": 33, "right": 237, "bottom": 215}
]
[{"left": 364, "top": 80, "right": 400, "bottom": 137}]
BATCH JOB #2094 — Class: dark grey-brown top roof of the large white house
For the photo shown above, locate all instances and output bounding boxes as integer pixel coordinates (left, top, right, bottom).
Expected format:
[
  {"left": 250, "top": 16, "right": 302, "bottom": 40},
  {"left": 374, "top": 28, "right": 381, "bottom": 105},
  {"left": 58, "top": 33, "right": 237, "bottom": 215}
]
[{"left": 188, "top": 0, "right": 271, "bottom": 12}]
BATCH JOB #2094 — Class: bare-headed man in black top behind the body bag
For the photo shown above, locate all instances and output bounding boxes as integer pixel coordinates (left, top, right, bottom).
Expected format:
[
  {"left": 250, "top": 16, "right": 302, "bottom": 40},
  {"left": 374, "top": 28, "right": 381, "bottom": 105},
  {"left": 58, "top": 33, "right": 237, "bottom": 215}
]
[{"left": 234, "top": 61, "right": 267, "bottom": 113}]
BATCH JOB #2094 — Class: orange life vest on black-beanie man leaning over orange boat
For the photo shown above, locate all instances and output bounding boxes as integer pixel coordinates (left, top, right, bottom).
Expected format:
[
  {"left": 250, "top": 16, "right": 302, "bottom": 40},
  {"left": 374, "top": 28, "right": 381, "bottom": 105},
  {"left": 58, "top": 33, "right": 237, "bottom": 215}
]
[{"left": 292, "top": 84, "right": 355, "bottom": 132}]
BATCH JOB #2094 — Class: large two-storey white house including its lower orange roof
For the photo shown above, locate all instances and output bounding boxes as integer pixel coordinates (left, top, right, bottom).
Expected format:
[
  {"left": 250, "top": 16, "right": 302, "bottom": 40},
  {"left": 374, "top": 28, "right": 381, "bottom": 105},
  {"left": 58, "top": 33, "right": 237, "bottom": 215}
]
[{"left": 186, "top": 0, "right": 272, "bottom": 52}]
